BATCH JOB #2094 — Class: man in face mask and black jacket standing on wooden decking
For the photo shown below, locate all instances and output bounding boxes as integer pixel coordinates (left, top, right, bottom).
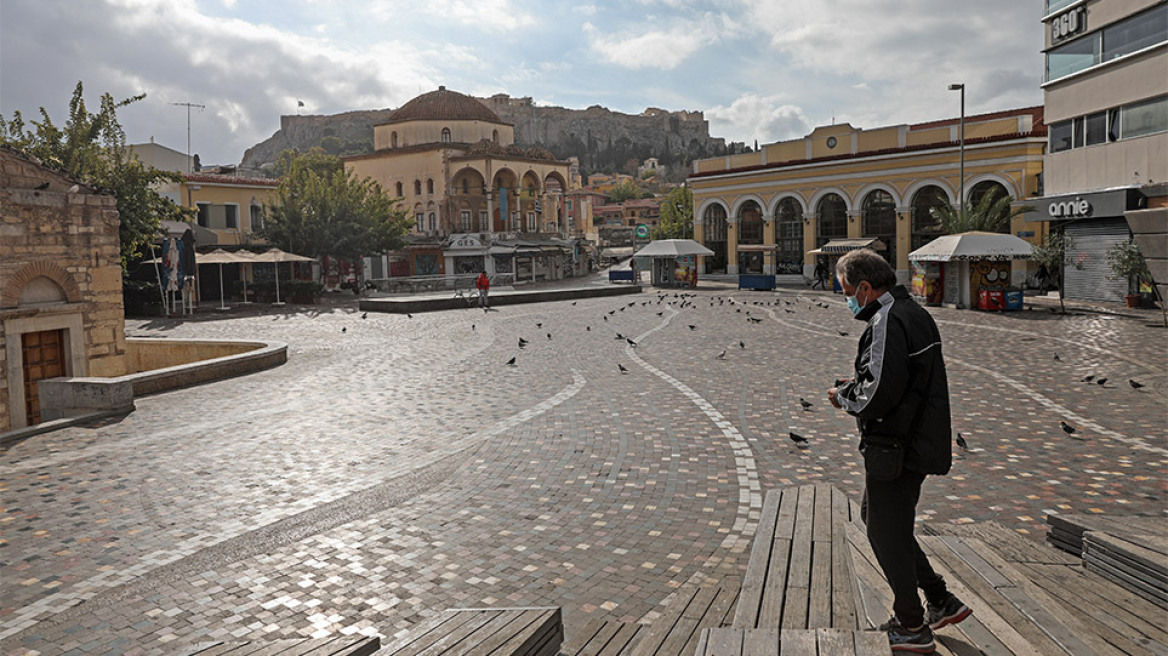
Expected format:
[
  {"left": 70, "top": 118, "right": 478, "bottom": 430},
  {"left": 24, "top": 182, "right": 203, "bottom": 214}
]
[{"left": 827, "top": 249, "right": 972, "bottom": 654}]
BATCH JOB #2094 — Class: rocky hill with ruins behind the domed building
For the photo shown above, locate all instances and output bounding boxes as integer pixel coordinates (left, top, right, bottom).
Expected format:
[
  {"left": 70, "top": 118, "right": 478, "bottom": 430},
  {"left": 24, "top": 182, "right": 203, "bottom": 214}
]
[{"left": 239, "top": 93, "right": 741, "bottom": 181}]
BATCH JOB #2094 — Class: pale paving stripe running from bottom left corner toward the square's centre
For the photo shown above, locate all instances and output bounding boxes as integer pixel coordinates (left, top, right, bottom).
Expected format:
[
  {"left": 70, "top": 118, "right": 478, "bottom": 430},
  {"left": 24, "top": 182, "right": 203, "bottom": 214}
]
[{"left": 0, "top": 369, "right": 588, "bottom": 640}]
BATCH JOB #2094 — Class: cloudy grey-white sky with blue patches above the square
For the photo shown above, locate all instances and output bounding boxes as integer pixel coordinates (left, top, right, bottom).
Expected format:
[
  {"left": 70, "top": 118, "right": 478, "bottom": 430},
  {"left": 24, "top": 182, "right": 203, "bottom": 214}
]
[{"left": 0, "top": 0, "right": 1043, "bottom": 165}]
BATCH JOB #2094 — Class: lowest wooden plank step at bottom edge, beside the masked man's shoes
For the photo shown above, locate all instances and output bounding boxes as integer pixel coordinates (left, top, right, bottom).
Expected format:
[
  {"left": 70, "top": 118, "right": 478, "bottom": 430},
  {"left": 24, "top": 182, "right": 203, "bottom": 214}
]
[{"left": 695, "top": 627, "right": 892, "bottom": 656}]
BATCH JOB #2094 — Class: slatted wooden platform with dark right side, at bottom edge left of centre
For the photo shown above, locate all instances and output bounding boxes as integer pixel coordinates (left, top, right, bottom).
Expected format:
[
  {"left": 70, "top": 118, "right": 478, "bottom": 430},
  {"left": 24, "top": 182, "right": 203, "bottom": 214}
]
[{"left": 377, "top": 607, "right": 564, "bottom": 656}]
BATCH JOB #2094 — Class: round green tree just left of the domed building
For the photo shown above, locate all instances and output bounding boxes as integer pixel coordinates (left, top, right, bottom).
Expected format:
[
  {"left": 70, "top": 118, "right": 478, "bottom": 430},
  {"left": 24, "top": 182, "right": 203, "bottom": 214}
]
[{"left": 259, "top": 148, "right": 410, "bottom": 261}]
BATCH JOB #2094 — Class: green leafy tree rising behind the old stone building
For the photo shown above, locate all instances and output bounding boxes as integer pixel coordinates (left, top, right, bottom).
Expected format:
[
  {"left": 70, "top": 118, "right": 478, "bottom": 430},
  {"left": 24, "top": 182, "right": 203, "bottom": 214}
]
[{"left": 0, "top": 82, "right": 194, "bottom": 272}]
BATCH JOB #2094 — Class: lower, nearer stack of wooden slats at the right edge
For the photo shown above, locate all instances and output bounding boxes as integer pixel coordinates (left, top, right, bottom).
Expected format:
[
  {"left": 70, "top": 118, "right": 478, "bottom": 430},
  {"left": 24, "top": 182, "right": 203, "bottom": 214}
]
[{"left": 1083, "top": 531, "right": 1168, "bottom": 608}]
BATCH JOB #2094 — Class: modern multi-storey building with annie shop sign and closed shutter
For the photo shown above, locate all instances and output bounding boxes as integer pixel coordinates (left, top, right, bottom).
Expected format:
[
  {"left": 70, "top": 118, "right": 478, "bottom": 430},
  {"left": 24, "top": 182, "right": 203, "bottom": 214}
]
[{"left": 1028, "top": 0, "right": 1168, "bottom": 301}]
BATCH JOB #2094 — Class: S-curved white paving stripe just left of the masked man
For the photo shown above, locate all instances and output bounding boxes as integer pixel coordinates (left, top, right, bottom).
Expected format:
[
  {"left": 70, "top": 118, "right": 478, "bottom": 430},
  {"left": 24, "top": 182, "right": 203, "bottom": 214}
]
[{"left": 625, "top": 308, "right": 763, "bottom": 551}]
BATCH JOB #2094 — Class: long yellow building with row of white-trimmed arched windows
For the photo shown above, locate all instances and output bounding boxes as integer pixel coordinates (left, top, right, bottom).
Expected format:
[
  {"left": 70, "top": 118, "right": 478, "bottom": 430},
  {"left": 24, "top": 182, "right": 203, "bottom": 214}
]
[{"left": 688, "top": 107, "right": 1047, "bottom": 282}]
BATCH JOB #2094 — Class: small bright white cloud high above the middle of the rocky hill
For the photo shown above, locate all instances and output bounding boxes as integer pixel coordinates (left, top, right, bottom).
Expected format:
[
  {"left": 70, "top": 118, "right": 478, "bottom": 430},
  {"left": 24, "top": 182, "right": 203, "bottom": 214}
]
[{"left": 584, "top": 14, "right": 724, "bottom": 70}]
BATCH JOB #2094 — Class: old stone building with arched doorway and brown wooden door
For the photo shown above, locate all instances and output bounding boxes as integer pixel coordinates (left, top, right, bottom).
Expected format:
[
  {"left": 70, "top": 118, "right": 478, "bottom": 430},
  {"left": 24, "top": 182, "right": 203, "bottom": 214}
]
[{"left": 0, "top": 148, "right": 126, "bottom": 432}]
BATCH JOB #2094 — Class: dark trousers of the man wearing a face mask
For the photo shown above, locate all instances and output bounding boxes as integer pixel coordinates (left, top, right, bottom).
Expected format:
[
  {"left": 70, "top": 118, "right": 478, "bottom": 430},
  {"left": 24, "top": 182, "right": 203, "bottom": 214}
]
[{"left": 861, "top": 470, "right": 948, "bottom": 628}]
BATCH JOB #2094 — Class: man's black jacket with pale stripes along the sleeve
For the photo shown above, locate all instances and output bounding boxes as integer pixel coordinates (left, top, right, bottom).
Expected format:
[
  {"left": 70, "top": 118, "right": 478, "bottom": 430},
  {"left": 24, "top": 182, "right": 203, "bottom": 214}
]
[{"left": 836, "top": 285, "right": 953, "bottom": 474}]
